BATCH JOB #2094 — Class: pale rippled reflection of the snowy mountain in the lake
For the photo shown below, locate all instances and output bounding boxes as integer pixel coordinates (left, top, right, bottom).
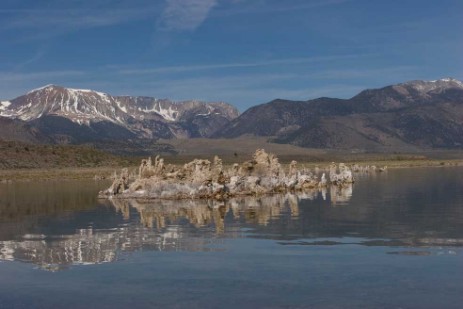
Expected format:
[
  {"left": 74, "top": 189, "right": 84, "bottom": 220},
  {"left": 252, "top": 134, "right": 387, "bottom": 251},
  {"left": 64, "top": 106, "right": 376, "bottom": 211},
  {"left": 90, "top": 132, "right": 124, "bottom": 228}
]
[{"left": 0, "top": 220, "right": 227, "bottom": 270}]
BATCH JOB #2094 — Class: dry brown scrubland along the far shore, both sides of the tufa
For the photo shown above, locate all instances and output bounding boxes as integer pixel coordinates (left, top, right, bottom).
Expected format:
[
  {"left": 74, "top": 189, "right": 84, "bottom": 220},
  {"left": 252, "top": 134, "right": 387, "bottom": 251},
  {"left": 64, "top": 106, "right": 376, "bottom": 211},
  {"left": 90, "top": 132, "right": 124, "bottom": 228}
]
[{"left": 0, "top": 137, "right": 463, "bottom": 181}]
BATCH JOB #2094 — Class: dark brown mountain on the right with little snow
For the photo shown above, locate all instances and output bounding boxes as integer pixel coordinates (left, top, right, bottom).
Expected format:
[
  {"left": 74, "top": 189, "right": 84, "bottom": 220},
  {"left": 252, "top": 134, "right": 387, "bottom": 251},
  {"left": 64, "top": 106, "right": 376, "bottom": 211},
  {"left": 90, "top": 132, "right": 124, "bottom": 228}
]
[{"left": 215, "top": 78, "right": 463, "bottom": 150}]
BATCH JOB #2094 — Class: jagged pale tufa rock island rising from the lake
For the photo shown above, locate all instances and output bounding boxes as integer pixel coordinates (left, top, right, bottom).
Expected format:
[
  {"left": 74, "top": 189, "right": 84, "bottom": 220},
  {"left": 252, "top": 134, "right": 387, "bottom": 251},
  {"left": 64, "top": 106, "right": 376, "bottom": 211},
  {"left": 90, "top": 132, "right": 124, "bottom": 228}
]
[{"left": 99, "top": 149, "right": 354, "bottom": 200}]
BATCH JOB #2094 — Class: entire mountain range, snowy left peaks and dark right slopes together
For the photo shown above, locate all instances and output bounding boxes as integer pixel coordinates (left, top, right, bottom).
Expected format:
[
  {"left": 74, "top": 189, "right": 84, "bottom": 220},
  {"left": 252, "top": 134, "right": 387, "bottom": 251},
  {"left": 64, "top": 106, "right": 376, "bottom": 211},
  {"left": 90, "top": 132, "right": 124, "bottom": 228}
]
[{"left": 0, "top": 78, "right": 463, "bottom": 151}]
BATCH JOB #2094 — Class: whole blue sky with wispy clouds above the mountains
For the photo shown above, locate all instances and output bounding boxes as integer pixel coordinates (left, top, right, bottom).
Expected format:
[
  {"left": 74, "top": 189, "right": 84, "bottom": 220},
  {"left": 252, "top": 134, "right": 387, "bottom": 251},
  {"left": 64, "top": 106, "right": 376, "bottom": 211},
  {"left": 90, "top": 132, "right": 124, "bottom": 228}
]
[{"left": 0, "top": 0, "right": 463, "bottom": 111}]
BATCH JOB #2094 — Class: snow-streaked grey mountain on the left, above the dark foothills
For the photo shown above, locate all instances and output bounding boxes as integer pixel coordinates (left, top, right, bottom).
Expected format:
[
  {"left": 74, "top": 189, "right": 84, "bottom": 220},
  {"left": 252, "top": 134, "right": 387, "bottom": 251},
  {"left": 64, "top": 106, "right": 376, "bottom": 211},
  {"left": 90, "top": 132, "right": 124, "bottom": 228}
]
[{"left": 0, "top": 85, "right": 239, "bottom": 138}]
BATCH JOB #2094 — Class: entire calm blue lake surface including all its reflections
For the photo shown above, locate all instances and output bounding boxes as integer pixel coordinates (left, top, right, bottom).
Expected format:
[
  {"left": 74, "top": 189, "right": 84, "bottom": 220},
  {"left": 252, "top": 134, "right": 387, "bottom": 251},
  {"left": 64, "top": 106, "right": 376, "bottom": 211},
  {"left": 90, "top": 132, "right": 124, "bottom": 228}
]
[{"left": 0, "top": 167, "right": 463, "bottom": 308}]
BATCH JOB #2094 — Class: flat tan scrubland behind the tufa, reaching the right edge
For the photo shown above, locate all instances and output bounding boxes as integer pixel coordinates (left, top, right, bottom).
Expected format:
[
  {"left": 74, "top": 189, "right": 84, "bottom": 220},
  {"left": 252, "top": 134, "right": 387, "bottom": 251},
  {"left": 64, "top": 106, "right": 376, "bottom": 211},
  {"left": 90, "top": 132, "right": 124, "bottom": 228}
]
[{"left": 162, "top": 137, "right": 463, "bottom": 166}]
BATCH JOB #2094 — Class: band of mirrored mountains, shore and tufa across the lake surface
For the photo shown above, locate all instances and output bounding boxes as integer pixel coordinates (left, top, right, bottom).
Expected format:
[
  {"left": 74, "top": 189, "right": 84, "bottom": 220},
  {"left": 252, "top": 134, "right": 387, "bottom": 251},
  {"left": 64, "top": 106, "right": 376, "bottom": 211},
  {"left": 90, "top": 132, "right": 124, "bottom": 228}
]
[{"left": 0, "top": 168, "right": 463, "bottom": 270}]
